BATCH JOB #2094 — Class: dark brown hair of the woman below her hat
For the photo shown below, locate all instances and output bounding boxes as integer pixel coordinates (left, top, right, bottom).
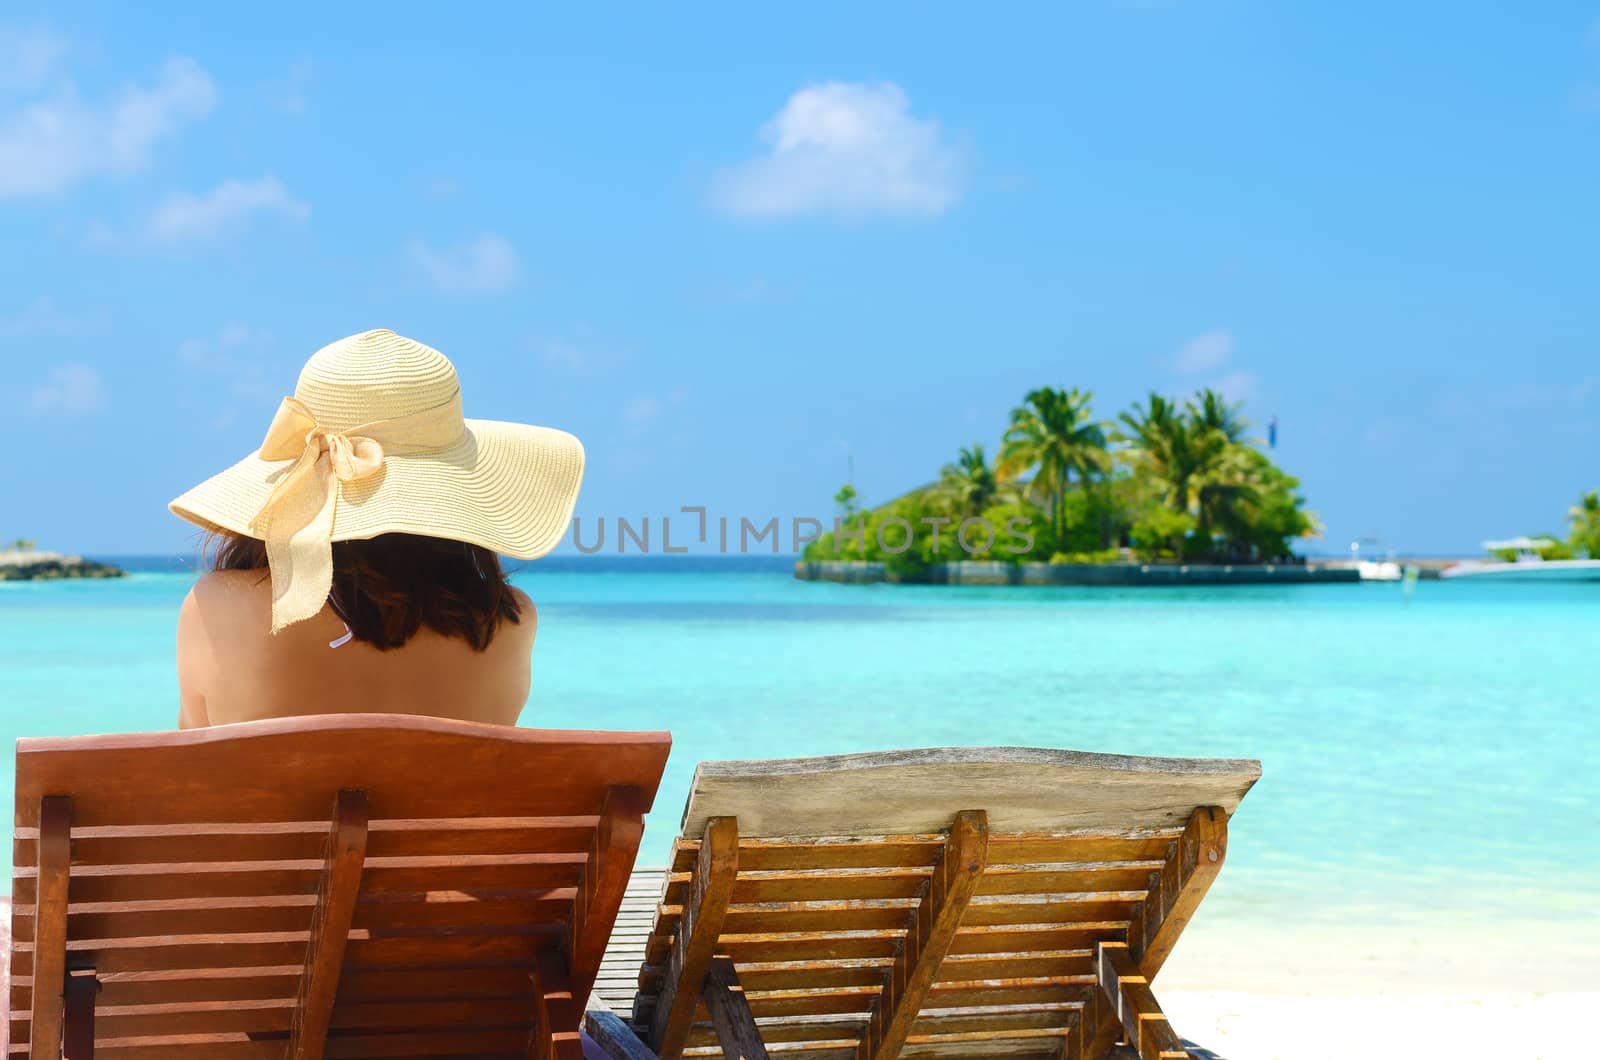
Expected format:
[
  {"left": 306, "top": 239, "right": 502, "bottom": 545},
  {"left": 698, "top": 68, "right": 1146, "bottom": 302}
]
[{"left": 206, "top": 532, "right": 522, "bottom": 652}]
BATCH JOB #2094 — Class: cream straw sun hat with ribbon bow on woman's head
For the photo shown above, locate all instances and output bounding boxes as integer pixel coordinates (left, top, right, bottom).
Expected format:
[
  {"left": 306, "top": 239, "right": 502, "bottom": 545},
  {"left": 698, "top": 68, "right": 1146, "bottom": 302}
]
[{"left": 170, "top": 330, "right": 584, "bottom": 632}]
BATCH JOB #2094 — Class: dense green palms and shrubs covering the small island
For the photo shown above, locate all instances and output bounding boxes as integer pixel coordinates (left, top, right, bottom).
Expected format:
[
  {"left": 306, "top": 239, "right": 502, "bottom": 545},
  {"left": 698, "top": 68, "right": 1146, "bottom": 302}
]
[{"left": 805, "top": 387, "right": 1318, "bottom": 576}]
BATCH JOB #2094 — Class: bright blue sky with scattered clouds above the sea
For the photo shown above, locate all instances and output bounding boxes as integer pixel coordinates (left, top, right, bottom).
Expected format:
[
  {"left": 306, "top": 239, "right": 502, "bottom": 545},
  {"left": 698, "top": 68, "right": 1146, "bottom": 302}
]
[{"left": 0, "top": 0, "right": 1600, "bottom": 552}]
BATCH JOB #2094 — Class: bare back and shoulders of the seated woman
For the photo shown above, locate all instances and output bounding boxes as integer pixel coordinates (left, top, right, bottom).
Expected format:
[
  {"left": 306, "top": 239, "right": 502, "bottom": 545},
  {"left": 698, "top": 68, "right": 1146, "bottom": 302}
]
[{"left": 178, "top": 570, "right": 538, "bottom": 729}]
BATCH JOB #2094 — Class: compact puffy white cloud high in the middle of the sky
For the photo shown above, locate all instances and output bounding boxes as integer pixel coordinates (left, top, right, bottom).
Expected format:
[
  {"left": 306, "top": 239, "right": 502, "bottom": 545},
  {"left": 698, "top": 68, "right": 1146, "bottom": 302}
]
[{"left": 712, "top": 82, "right": 965, "bottom": 218}]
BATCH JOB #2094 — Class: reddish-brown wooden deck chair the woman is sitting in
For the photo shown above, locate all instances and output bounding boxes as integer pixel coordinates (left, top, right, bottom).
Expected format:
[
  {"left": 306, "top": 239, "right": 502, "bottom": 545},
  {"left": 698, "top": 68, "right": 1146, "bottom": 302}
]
[{"left": 10, "top": 714, "right": 670, "bottom": 1060}]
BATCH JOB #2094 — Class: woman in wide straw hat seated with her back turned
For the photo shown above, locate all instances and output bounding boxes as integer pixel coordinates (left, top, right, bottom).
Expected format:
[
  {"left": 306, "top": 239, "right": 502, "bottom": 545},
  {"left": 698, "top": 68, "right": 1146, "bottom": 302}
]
[{"left": 171, "top": 331, "right": 584, "bottom": 729}]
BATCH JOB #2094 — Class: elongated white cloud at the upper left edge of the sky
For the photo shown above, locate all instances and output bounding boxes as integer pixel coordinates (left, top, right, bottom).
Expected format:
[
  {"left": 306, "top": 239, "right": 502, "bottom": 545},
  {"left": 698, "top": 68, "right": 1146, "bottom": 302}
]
[{"left": 0, "top": 56, "right": 216, "bottom": 199}]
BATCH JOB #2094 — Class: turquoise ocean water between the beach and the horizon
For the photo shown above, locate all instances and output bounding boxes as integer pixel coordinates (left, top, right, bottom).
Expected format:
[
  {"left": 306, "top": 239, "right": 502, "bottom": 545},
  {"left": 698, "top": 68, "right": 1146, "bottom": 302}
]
[{"left": 0, "top": 559, "right": 1600, "bottom": 930}]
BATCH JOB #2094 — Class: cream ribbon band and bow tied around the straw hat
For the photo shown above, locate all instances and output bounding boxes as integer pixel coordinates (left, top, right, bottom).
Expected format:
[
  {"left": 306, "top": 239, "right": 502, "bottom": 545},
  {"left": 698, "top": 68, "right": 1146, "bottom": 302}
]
[{"left": 250, "top": 391, "right": 466, "bottom": 632}]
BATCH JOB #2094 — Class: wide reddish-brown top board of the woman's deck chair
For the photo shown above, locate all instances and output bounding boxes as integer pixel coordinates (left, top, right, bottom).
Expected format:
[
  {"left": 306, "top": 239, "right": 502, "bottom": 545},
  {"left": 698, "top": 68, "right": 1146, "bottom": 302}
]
[{"left": 16, "top": 714, "right": 669, "bottom": 828}]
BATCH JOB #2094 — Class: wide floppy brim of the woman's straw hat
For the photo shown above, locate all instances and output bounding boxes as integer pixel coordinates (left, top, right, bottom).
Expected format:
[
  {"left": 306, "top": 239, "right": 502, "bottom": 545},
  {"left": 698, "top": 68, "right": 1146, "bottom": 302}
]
[{"left": 168, "top": 420, "right": 584, "bottom": 559}]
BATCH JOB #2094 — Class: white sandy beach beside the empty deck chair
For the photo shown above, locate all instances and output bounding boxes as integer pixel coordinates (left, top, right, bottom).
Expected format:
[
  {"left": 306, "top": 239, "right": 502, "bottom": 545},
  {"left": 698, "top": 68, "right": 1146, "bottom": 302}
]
[{"left": 0, "top": 897, "right": 1600, "bottom": 1060}]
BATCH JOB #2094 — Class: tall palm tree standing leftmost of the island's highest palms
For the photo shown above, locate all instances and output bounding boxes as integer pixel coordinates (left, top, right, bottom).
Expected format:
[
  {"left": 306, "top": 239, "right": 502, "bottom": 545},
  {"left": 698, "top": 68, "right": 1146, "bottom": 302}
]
[{"left": 1000, "top": 386, "right": 1110, "bottom": 535}]
